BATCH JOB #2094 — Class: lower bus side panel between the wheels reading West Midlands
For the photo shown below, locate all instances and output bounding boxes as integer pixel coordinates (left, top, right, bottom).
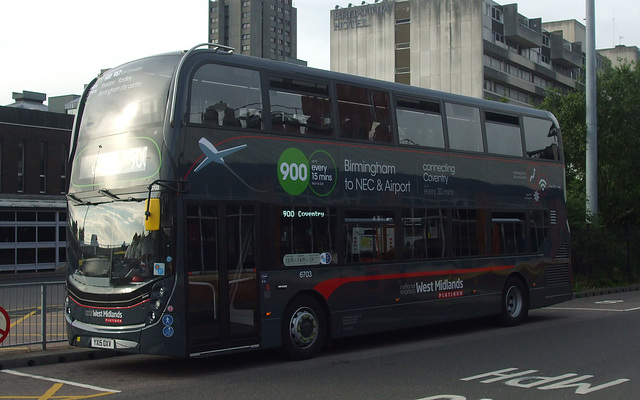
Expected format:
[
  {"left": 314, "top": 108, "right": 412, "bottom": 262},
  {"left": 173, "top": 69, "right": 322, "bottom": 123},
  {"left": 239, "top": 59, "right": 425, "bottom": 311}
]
[{"left": 318, "top": 262, "right": 513, "bottom": 338}]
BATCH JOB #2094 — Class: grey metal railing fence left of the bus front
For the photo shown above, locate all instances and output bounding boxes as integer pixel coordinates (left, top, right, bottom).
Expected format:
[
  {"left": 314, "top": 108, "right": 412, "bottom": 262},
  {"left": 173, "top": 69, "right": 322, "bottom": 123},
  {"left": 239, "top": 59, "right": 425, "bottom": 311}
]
[{"left": 0, "top": 282, "right": 67, "bottom": 350}]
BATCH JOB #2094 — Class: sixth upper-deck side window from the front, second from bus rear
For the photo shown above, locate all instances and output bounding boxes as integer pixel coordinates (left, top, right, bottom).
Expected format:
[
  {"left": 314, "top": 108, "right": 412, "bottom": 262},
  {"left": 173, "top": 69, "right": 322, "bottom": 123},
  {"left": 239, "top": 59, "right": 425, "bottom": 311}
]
[{"left": 485, "top": 111, "right": 522, "bottom": 157}]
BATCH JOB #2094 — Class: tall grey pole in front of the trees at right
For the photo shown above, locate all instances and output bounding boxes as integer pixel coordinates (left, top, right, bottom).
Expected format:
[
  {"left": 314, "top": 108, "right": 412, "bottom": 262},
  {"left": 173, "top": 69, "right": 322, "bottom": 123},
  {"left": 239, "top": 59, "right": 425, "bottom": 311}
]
[{"left": 585, "top": 0, "right": 598, "bottom": 217}]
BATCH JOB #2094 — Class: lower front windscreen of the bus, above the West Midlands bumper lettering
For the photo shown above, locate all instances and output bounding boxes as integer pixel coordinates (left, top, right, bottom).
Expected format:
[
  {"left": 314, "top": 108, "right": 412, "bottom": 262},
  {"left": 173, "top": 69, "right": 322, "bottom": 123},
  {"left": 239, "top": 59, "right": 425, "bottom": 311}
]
[{"left": 67, "top": 202, "right": 173, "bottom": 294}]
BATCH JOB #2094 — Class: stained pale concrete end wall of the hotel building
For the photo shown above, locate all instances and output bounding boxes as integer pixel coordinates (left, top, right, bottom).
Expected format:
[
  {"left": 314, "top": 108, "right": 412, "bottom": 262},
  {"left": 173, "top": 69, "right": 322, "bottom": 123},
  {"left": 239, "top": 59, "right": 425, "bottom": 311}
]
[{"left": 330, "top": 0, "right": 483, "bottom": 98}]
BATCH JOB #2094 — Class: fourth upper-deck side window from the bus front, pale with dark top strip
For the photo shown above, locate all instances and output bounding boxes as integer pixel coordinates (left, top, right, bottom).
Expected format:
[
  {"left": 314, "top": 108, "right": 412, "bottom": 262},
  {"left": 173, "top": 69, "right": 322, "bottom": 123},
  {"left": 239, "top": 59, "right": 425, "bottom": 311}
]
[{"left": 396, "top": 99, "right": 444, "bottom": 148}]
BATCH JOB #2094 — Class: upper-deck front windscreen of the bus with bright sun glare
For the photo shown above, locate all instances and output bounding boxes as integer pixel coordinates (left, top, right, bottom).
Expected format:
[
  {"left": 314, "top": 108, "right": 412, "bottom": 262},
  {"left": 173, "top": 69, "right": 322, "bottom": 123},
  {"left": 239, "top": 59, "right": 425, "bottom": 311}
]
[{"left": 80, "top": 55, "right": 180, "bottom": 140}]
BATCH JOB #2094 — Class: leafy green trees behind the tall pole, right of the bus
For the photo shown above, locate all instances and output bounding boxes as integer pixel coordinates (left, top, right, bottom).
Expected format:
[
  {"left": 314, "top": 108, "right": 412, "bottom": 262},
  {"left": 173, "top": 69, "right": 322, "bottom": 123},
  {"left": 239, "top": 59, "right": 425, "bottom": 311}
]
[{"left": 541, "top": 64, "right": 640, "bottom": 231}]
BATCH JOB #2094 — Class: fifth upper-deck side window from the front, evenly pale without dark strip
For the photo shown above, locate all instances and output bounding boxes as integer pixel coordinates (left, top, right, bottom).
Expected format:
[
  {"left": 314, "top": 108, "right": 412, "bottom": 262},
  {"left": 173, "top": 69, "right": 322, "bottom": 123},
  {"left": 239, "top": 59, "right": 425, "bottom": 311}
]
[{"left": 446, "top": 103, "right": 484, "bottom": 153}]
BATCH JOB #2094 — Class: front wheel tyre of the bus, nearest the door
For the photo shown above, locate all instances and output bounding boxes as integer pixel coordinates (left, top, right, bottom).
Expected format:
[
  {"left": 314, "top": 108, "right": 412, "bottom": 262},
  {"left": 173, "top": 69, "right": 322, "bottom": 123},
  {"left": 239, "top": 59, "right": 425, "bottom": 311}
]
[{"left": 282, "top": 296, "right": 327, "bottom": 360}]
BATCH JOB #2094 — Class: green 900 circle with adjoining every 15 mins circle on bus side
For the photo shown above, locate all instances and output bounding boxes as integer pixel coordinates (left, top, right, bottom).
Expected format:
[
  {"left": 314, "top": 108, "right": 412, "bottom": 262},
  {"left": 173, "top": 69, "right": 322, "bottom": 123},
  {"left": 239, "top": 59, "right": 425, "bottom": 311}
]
[{"left": 277, "top": 147, "right": 338, "bottom": 196}]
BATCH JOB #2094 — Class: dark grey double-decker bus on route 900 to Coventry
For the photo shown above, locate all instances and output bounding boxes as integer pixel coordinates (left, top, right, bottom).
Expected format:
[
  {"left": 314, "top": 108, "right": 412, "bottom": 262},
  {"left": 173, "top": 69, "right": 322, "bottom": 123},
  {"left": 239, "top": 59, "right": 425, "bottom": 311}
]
[{"left": 66, "top": 44, "right": 572, "bottom": 359}]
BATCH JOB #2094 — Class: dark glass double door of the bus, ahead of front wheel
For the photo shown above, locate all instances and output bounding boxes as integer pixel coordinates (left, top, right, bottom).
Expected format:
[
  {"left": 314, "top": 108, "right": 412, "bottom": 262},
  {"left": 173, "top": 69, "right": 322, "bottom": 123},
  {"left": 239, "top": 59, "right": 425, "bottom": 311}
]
[{"left": 186, "top": 203, "right": 258, "bottom": 353}]
